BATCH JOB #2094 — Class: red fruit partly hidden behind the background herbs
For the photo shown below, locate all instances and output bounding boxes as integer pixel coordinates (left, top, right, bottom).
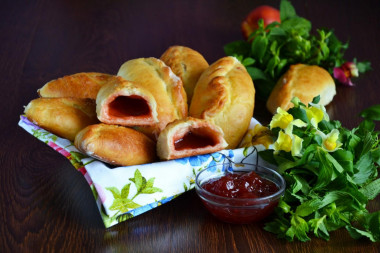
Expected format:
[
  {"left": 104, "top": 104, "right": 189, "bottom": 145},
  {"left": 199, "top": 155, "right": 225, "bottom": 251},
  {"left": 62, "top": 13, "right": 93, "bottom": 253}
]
[{"left": 241, "top": 5, "right": 281, "bottom": 39}]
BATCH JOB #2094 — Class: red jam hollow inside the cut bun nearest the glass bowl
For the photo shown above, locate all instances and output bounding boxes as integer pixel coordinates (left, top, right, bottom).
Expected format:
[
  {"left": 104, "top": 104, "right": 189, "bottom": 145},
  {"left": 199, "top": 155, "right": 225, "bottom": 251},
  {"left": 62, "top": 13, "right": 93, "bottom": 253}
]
[{"left": 174, "top": 131, "right": 216, "bottom": 150}]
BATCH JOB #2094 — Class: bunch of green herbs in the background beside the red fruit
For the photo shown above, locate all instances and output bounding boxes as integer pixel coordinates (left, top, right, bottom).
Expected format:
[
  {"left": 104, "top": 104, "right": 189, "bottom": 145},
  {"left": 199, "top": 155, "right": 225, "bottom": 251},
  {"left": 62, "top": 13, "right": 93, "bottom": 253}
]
[{"left": 224, "top": 0, "right": 370, "bottom": 101}]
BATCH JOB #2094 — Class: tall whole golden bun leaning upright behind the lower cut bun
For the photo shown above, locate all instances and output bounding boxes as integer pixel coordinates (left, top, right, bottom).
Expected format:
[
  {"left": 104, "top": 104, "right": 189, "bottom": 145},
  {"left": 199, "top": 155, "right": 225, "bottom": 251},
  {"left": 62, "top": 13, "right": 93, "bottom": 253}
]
[{"left": 189, "top": 56, "right": 255, "bottom": 149}]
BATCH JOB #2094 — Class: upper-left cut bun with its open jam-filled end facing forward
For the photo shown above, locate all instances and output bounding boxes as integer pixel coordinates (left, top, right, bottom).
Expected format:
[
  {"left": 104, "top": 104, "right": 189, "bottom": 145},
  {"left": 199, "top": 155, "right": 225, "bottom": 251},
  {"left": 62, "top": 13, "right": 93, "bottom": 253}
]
[{"left": 96, "top": 76, "right": 158, "bottom": 126}]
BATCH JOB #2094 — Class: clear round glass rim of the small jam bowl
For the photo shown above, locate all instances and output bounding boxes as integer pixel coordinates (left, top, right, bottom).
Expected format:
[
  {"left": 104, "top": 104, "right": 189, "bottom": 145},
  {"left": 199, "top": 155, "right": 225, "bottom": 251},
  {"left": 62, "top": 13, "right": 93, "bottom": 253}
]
[{"left": 195, "top": 162, "right": 286, "bottom": 208}]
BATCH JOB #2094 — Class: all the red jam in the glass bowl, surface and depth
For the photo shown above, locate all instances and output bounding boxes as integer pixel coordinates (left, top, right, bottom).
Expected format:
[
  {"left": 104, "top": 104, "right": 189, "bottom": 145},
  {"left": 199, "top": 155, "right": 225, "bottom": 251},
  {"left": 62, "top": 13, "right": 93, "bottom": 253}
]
[{"left": 202, "top": 172, "right": 279, "bottom": 224}]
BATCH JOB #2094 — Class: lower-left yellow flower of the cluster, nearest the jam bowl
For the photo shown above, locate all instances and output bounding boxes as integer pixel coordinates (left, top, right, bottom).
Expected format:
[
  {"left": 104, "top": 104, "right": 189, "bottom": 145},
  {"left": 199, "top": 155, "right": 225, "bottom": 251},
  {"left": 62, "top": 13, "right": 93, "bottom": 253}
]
[{"left": 273, "top": 131, "right": 303, "bottom": 156}]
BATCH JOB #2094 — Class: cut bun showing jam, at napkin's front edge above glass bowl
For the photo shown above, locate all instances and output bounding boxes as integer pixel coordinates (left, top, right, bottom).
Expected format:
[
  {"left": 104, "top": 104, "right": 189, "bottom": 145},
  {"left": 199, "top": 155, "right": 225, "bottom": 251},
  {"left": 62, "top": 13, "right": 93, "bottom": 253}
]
[{"left": 157, "top": 117, "right": 227, "bottom": 160}]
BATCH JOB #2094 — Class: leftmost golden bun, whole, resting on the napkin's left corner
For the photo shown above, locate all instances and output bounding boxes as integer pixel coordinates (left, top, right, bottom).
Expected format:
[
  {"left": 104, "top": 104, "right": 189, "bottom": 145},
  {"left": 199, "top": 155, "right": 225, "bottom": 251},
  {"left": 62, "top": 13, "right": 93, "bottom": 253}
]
[{"left": 24, "top": 98, "right": 99, "bottom": 141}]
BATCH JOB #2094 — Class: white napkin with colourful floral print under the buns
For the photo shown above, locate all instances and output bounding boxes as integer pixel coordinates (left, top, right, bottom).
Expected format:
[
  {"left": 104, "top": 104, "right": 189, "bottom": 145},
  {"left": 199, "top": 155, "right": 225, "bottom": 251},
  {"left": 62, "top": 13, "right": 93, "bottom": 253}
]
[{"left": 19, "top": 115, "right": 265, "bottom": 228}]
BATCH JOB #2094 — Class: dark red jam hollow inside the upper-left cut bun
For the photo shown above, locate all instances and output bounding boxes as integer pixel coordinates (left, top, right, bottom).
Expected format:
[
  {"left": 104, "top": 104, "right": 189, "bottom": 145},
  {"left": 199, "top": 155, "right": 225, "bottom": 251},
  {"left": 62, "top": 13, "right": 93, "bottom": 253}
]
[{"left": 108, "top": 96, "right": 150, "bottom": 117}]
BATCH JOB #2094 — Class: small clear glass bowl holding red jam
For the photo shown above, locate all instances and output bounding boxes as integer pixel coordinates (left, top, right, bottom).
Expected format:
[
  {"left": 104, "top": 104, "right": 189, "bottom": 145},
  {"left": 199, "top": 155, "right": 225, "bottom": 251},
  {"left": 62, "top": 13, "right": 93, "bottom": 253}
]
[{"left": 195, "top": 163, "right": 286, "bottom": 224}]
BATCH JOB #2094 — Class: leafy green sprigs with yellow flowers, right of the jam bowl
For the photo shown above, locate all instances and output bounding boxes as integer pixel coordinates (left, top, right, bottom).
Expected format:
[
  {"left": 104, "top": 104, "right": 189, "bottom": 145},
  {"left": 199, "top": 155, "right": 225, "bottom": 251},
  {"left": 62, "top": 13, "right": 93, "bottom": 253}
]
[{"left": 259, "top": 97, "right": 380, "bottom": 242}]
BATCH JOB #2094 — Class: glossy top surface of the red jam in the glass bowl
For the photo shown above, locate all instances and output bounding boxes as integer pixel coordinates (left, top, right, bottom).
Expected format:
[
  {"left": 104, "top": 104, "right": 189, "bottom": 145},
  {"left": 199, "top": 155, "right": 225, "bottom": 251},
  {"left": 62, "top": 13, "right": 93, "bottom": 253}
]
[{"left": 202, "top": 171, "right": 278, "bottom": 199}]
